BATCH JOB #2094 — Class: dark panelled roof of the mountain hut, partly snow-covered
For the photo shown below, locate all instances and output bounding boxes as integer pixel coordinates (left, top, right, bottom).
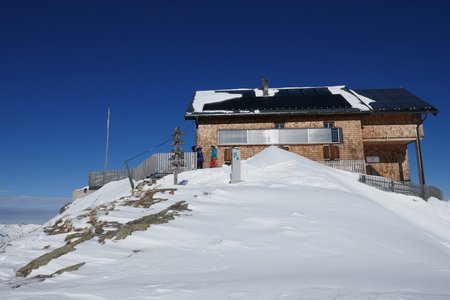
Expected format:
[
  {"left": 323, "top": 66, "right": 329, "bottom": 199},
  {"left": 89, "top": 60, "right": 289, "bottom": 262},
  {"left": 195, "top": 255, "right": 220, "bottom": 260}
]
[{"left": 185, "top": 87, "right": 438, "bottom": 119}]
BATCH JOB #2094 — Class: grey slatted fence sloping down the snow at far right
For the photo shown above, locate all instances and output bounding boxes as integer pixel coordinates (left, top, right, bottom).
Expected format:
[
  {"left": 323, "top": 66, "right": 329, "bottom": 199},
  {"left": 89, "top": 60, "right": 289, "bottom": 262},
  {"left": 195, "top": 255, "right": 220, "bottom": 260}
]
[{"left": 359, "top": 174, "right": 444, "bottom": 200}]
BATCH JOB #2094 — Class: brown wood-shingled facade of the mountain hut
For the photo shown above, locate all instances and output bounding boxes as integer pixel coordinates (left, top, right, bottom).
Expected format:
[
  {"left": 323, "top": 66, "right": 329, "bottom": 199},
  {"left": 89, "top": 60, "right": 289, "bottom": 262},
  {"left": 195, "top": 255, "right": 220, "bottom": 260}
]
[{"left": 196, "top": 114, "right": 423, "bottom": 180}]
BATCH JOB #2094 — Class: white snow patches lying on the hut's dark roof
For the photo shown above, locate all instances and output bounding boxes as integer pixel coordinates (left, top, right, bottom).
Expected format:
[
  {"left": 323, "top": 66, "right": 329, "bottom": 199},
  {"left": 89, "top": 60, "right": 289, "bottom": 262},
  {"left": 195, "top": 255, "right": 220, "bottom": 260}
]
[{"left": 191, "top": 85, "right": 374, "bottom": 113}]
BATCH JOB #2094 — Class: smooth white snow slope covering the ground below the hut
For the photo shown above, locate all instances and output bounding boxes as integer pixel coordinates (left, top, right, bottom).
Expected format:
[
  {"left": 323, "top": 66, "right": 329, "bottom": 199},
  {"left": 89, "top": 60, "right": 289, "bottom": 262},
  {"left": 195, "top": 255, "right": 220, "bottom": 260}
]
[{"left": 0, "top": 147, "right": 450, "bottom": 300}]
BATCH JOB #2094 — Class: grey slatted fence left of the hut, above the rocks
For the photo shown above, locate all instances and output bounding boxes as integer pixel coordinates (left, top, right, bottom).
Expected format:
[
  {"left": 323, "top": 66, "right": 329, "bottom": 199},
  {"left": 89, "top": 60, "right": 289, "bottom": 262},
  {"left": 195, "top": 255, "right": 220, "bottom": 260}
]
[{"left": 88, "top": 152, "right": 197, "bottom": 189}]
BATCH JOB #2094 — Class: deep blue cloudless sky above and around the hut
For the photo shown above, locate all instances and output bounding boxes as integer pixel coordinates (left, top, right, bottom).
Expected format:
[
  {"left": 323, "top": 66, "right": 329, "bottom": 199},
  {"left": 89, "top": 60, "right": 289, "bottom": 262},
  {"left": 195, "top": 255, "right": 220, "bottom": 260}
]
[{"left": 0, "top": 0, "right": 450, "bottom": 213}]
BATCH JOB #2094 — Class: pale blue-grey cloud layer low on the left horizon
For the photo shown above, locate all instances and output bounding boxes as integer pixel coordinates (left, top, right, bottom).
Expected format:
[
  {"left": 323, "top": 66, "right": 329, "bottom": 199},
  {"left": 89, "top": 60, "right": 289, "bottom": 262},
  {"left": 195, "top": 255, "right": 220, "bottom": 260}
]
[{"left": 0, "top": 195, "right": 71, "bottom": 224}]
